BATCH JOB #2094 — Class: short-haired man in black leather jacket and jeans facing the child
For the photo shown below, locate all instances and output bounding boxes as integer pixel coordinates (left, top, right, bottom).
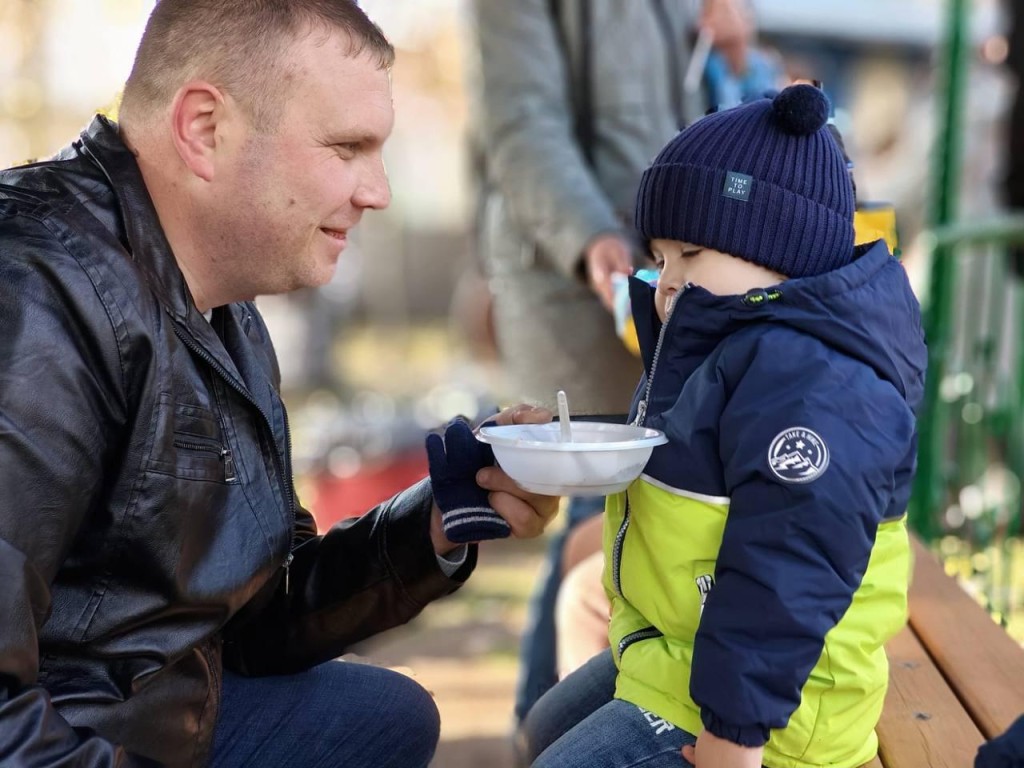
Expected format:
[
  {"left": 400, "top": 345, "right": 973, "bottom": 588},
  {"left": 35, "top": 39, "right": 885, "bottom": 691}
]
[{"left": 0, "top": 0, "right": 555, "bottom": 768}]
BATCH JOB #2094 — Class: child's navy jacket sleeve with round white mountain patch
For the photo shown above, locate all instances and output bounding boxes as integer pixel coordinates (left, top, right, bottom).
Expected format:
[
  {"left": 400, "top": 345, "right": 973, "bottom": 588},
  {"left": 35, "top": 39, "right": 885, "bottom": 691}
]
[{"left": 690, "top": 335, "right": 915, "bottom": 746}]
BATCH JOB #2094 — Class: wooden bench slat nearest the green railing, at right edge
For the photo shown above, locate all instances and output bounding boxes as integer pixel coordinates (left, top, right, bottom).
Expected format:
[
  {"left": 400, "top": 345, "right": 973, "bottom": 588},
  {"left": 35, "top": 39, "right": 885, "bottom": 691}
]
[{"left": 910, "top": 538, "right": 1024, "bottom": 741}]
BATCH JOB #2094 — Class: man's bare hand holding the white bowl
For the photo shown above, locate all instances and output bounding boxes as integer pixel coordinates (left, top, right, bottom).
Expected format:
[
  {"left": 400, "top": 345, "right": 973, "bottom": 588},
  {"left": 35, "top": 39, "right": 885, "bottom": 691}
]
[{"left": 430, "top": 406, "right": 559, "bottom": 555}]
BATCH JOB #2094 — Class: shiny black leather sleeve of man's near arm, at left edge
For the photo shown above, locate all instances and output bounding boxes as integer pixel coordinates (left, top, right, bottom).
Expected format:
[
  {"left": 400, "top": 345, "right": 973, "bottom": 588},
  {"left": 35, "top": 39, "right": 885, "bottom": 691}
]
[{"left": 0, "top": 219, "right": 153, "bottom": 768}]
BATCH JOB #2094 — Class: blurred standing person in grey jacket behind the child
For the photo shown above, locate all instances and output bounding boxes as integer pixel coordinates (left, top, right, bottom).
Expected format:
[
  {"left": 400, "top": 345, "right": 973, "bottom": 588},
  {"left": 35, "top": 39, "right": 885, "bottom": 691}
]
[{"left": 473, "top": 0, "right": 752, "bottom": 733}]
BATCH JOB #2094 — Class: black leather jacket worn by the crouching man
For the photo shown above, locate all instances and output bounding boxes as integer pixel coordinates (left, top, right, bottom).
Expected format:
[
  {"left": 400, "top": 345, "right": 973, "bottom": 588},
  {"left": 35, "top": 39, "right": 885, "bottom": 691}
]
[{"left": 0, "top": 118, "right": 475, "bottom": 768}]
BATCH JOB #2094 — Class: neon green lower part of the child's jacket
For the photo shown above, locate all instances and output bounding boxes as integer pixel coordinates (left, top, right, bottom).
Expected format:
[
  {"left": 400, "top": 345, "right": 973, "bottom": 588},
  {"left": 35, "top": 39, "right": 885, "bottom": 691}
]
[{"left": 604, "top": 478, "right": 909, "bottom": 768}]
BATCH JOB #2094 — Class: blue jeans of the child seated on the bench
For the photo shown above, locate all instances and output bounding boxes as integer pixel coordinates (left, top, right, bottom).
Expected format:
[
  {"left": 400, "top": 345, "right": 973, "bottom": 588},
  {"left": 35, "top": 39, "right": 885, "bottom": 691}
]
[{"left": 522, "top": 650, "right": 696, "bottom": 768}]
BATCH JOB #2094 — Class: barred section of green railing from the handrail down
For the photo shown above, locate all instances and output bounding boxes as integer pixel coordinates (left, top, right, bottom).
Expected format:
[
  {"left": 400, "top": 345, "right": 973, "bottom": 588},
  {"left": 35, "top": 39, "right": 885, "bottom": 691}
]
[{"left": 910, "top": 214, "right": 1024, "bottom": 546}]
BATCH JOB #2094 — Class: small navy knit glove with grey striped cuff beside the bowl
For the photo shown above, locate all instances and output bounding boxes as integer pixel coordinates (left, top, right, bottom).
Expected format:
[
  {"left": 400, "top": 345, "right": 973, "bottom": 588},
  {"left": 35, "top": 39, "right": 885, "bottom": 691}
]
[{"left": 427, "top": 419, "right": 512, "bottom": 544}]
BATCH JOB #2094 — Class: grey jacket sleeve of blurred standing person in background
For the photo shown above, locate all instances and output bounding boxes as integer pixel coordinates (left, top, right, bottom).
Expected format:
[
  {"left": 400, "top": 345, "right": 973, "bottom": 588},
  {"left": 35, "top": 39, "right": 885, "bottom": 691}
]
[{"left": 473, "top": 0, "right": 623, "bottom": 275}]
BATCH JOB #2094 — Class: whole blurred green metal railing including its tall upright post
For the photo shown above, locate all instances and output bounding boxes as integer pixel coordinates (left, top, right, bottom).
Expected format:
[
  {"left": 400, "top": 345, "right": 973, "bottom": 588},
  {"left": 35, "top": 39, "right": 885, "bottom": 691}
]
[{"left": 909, "top": 0, "right": 1024, "bottom": 638}]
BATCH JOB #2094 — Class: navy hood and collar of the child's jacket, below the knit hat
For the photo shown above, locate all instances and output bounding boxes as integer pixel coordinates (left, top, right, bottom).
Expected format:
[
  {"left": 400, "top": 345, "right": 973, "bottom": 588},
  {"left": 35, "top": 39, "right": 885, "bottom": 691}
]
[{"left": 630, "top": 241, "right": 928, "bottom": 413}]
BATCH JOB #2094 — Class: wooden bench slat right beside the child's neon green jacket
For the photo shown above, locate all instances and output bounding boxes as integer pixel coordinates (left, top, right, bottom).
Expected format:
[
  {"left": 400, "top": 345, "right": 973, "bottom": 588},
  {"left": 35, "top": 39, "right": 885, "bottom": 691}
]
[{"left": 877, "top": 628, "right": 984, "bottom": 768}]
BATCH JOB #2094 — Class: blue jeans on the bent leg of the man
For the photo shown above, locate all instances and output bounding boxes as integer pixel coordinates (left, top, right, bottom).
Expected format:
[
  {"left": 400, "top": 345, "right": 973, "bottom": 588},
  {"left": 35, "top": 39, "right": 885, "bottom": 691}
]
[{"left": 210, "top": 662, "right": 440, "bottom": 768}]
